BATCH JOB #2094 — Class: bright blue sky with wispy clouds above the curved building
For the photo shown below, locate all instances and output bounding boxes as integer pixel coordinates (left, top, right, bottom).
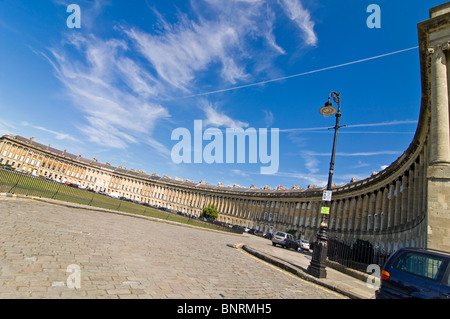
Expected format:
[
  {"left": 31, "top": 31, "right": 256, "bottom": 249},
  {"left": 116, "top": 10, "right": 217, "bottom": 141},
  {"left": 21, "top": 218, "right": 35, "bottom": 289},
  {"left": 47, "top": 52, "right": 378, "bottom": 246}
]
[{"left": 0, "top": 0, "right": 442, "bottom": 188}]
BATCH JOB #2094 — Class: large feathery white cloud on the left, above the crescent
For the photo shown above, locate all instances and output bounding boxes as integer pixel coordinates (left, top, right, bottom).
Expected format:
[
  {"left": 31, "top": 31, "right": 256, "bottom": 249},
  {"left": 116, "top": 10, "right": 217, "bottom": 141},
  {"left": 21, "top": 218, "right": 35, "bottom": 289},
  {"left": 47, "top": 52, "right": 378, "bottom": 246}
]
[{"left": 41, "top": 35, "right": 169, "bottom": 152}]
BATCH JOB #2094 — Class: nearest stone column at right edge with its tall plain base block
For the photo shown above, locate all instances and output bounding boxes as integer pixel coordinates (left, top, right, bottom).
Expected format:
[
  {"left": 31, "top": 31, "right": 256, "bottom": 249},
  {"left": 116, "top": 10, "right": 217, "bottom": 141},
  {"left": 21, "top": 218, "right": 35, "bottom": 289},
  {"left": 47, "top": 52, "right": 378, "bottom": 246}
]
[{"left": 425, "top": 23, "right": 450, "bottom": 251}]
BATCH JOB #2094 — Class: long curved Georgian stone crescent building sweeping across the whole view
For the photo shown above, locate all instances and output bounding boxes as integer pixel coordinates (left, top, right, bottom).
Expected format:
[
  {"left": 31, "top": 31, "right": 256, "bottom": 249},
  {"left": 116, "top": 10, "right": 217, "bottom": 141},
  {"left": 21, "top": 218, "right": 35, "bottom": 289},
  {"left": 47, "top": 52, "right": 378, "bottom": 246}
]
[{"left": 0, "top": 2, "right": 450, "bottom": 252}]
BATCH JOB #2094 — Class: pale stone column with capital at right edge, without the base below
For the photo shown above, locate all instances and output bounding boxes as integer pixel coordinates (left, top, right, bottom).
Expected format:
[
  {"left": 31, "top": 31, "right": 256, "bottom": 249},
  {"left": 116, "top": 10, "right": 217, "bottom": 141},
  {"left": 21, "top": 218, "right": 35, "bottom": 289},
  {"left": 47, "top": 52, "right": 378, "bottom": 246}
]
[{"left": 428, "top": 43, "right": 450, "bottom": 165}]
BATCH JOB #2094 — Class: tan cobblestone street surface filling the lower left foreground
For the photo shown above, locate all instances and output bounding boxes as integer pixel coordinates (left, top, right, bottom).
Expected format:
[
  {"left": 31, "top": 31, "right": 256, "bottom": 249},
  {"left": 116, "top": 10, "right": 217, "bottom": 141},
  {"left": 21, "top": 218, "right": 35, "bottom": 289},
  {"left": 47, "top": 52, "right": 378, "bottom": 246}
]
[{"left": 0, "top": 198, "right": 343, "bottom": 299}]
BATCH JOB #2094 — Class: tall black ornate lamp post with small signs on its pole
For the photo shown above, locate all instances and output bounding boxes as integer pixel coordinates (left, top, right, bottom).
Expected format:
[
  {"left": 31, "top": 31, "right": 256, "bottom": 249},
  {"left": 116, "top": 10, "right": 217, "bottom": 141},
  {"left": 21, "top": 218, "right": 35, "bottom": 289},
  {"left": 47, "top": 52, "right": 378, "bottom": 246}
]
[{"left": 308, "top": 92, "right": 345, "bottom": 278}]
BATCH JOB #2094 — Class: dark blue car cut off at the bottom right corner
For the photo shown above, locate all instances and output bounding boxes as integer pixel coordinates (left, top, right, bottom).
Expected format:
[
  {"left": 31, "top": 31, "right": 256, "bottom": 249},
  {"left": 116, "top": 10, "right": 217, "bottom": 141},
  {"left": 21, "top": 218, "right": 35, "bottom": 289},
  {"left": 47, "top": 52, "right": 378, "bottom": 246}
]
[{"left": 375, "top": 248, "right": 450, "bottom": 299}]
